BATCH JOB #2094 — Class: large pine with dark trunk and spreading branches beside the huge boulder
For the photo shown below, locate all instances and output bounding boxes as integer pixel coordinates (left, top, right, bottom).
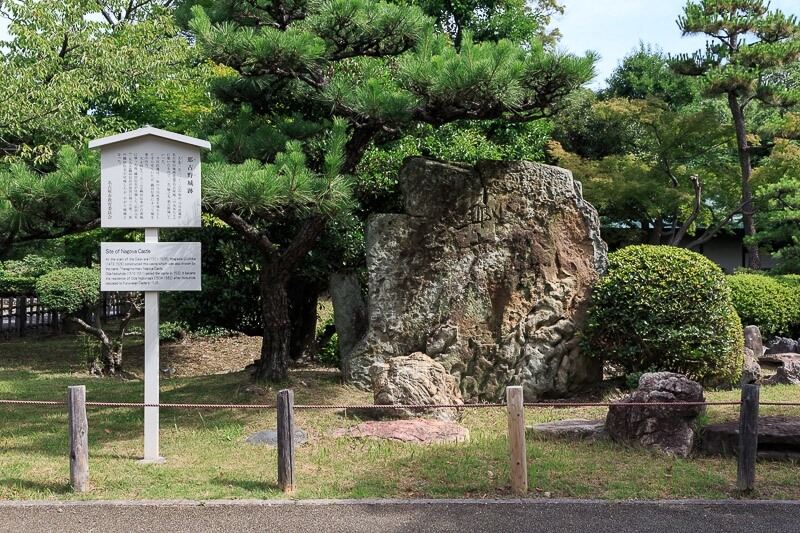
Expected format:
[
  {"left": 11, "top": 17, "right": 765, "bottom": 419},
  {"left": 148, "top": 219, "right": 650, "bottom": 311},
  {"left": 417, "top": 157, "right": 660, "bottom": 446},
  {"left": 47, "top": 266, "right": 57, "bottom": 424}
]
[{"left": 190, "top": 0, "right": 594, "bottom": 380}]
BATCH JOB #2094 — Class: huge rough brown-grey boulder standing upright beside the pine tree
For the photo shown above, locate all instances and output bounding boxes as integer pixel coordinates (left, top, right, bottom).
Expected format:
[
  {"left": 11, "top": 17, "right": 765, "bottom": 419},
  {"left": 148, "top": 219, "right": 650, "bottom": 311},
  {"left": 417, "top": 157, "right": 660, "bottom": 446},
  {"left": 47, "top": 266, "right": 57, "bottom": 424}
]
[{"left": 342, "top": 158, "right": 607, "bottom": 401}]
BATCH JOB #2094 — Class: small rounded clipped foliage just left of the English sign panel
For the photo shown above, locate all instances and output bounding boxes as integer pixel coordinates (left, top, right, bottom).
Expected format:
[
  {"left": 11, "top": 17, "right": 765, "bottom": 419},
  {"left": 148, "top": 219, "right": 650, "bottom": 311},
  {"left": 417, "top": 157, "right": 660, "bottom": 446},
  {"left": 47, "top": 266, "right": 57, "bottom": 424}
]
[{"left": 36, "top": 268, "right": 100, "bottom": 315}]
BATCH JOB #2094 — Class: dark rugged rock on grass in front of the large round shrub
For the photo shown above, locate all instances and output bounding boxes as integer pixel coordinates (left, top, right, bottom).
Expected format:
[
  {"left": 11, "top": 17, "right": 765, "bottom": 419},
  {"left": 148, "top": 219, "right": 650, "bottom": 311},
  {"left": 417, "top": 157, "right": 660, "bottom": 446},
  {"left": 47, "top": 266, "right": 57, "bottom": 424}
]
[{"left": 606, "top": 372, "right": 705, "bottom": 457}]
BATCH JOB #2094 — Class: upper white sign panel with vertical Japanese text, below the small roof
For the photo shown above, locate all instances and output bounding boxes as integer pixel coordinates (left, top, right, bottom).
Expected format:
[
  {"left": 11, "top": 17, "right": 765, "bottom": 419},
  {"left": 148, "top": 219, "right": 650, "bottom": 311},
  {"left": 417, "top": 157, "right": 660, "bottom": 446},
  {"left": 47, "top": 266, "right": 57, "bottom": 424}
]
[{"left": 100, "top": 136, "right": 201, "bottom": 228}]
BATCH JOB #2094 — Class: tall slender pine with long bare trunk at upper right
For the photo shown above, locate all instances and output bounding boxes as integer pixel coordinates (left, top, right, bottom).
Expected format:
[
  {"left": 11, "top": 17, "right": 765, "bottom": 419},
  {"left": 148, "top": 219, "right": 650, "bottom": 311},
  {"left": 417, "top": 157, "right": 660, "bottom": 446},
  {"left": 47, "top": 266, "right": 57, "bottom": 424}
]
[{"left": 673, "top": 0, "right": 800, "bottom": 269}]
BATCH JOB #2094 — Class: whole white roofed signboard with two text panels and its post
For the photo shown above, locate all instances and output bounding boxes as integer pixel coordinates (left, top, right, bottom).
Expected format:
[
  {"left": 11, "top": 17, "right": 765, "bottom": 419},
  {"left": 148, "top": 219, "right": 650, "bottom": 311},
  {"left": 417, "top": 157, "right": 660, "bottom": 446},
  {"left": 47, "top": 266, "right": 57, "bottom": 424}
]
[{"left": 89, "top": 127, "right": 211, "bottom": 463}]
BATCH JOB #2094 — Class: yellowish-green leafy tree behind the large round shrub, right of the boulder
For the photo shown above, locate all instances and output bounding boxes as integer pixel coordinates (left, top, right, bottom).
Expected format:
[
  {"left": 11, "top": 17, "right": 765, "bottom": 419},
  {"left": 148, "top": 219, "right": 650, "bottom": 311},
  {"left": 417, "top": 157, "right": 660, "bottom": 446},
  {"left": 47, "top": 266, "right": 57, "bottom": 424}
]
[{"left": 550, "top": 97, "right": 738, "bottom": 248}]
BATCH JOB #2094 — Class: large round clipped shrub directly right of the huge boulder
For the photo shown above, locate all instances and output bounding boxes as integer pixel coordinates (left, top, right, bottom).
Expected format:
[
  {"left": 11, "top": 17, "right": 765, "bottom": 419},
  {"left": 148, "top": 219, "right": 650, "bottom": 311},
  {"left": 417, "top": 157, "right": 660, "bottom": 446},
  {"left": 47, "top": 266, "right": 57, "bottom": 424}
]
[{"left": 585, "top": 245, "right": 744, "bottom": 384}]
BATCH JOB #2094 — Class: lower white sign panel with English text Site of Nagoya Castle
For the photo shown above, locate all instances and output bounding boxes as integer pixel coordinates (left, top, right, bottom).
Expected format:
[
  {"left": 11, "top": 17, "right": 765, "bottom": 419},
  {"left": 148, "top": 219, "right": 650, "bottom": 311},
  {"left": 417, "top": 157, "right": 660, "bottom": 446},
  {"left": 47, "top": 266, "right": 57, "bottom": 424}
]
[{"left": 100, "top": 242, "right": 201, "bottom": 291}]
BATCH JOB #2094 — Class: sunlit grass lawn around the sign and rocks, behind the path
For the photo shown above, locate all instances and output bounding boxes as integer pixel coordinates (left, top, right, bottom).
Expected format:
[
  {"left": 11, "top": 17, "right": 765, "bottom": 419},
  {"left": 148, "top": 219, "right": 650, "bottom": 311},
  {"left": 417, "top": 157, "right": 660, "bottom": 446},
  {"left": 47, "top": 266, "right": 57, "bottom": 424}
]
[{"left": 0, "top": 328, "right": 800, "bottom": 500}]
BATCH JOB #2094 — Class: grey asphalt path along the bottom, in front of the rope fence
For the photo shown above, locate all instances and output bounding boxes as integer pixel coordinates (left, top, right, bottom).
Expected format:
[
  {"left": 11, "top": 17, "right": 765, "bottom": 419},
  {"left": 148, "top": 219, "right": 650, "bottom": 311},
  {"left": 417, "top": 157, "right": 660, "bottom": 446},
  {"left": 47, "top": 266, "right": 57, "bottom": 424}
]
[{"left": 0, "top": 499, "right": 800, "bottom": 533}]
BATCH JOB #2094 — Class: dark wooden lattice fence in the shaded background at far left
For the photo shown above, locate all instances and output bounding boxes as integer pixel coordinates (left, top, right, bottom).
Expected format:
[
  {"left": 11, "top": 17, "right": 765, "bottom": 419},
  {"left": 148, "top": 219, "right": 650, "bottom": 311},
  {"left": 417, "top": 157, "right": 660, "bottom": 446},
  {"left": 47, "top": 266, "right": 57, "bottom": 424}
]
[{"left": 0, "top": 292, "right": 127, "bottom": 339}]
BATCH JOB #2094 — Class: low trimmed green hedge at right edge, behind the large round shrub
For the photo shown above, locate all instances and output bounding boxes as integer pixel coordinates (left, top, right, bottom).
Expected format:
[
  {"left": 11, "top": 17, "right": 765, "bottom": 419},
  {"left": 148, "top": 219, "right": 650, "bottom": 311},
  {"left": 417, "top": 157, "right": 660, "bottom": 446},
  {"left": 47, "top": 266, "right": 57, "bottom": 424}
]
[{"left": 728, "top": 272, "right": 800, "bottom": 339}]
